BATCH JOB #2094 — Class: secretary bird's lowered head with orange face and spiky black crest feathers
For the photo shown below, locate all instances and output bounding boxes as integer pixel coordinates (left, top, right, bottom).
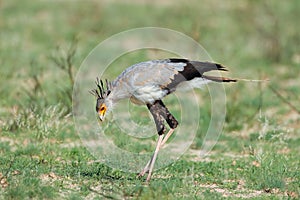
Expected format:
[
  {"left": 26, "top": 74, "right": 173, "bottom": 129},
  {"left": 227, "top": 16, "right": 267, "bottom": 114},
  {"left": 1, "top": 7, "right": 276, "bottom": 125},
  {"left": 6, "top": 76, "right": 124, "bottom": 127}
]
[{"left": 90, "top": 78, "right": 111, "bottom": 121}]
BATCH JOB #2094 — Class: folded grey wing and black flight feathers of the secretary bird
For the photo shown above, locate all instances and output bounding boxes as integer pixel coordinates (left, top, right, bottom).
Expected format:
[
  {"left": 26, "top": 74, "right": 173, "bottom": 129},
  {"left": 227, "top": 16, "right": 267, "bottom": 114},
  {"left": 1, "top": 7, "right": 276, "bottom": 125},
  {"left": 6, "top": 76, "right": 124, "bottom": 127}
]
[{"left": 114, "top": 59, "right": 234, "bottom": 103}]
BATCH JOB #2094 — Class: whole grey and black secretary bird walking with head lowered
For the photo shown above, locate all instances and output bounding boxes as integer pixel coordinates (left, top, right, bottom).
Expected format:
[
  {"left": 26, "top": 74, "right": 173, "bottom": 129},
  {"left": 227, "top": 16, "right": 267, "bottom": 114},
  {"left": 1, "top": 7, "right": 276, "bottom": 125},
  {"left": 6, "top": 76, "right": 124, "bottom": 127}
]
[{"left": 92, "top": 58, "right": 236, "bottom": 181}]
